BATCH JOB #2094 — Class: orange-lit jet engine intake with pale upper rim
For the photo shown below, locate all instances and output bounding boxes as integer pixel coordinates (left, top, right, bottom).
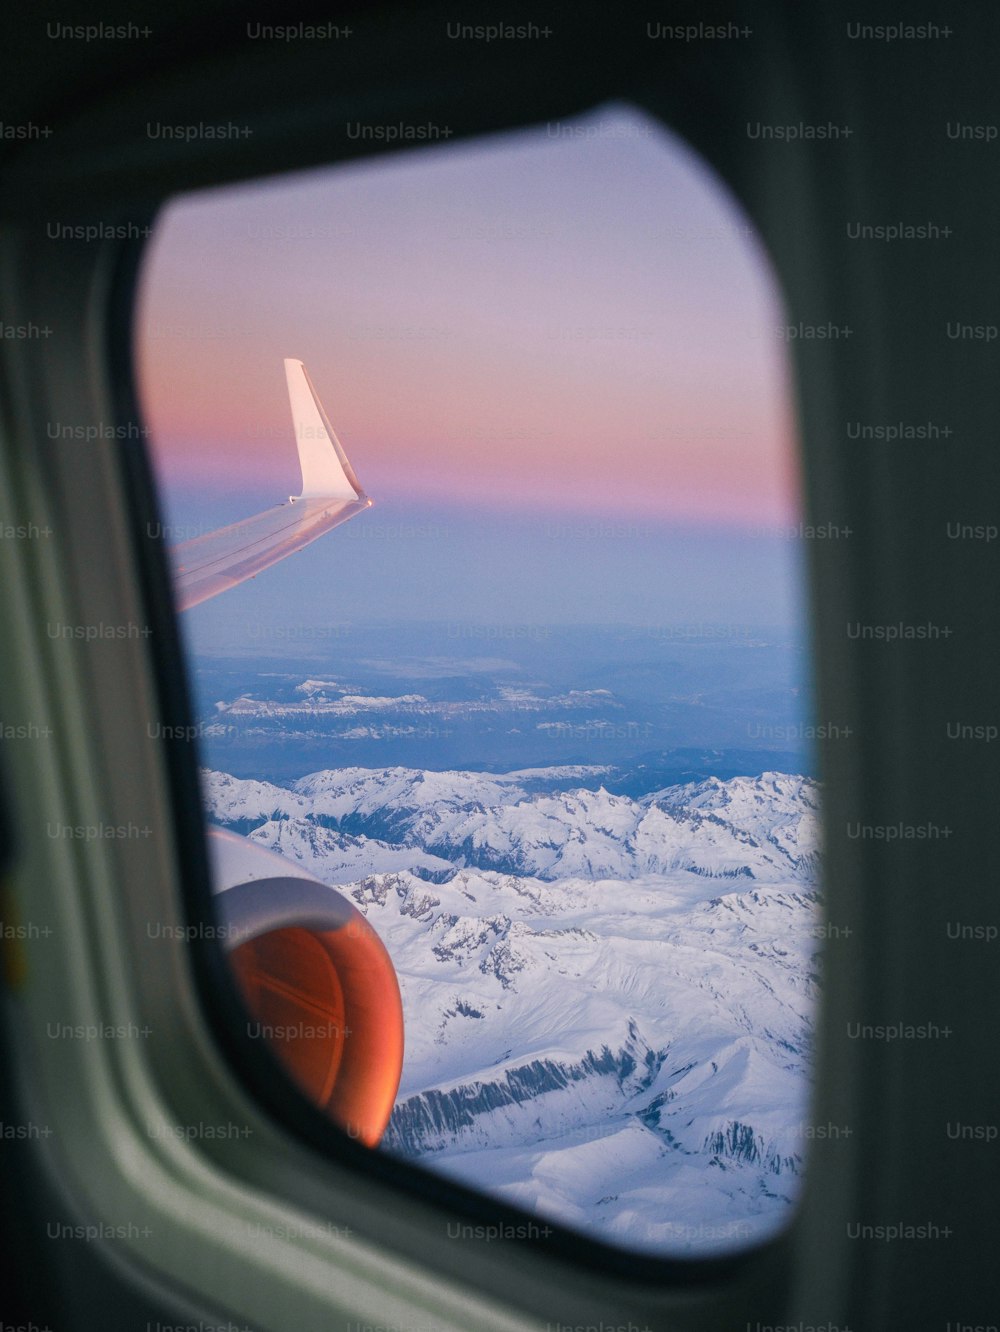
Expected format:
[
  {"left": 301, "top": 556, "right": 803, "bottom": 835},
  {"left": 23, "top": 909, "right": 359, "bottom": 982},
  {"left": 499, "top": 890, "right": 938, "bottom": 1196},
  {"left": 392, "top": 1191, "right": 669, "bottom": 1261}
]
[{"left": 214, "top": 873, "right": 403, "bottom": 1147}]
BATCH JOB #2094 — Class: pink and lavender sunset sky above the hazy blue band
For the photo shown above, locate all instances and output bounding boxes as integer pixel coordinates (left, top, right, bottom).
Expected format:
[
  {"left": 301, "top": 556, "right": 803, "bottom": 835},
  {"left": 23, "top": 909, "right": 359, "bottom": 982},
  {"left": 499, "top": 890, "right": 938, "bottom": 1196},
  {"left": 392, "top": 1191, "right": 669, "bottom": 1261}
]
[{"left": 137, "top": 109, "right": 798, "bottom": 527}]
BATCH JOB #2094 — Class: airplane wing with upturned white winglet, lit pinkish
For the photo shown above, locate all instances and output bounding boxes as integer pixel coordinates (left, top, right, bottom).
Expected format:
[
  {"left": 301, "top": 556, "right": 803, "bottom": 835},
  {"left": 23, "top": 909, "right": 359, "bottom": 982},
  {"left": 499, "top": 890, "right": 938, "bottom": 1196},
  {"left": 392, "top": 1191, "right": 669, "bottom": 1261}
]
[{"left": 172, "top": 358, "right": 372, "bottom": 610}]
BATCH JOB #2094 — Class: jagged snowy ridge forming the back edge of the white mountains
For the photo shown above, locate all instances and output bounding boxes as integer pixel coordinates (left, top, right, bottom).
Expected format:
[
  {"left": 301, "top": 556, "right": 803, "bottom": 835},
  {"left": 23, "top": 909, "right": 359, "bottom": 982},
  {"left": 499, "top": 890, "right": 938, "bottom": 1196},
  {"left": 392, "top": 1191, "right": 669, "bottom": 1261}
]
[{"left": 208, "top": 767, "right": 818, "bottom": 883}]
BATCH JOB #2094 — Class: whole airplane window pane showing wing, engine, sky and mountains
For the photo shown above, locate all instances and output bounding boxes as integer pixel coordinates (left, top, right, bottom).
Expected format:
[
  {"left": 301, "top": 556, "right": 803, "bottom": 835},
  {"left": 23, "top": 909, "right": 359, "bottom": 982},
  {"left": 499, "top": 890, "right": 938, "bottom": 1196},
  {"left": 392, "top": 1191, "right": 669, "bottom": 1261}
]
[{"left": 136, "top": 107, "right": 820, "bottom": 1256}]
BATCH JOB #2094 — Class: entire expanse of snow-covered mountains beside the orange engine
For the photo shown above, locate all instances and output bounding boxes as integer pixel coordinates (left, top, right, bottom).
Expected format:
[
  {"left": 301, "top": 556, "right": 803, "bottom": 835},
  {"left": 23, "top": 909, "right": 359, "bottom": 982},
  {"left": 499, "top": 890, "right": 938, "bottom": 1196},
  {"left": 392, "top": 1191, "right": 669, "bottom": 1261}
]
[{"left": 205, "top": 767, "right": 818, "bottom": 1251}]
